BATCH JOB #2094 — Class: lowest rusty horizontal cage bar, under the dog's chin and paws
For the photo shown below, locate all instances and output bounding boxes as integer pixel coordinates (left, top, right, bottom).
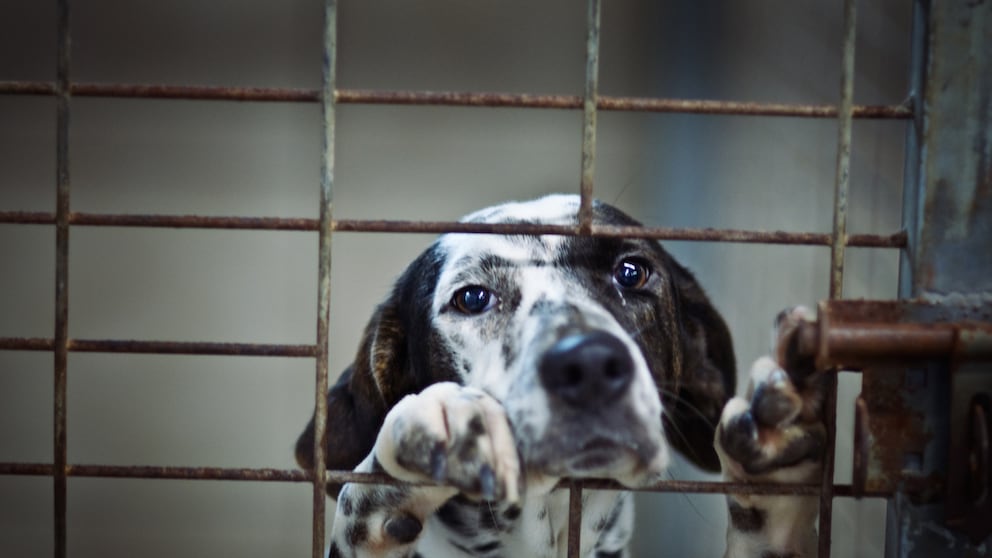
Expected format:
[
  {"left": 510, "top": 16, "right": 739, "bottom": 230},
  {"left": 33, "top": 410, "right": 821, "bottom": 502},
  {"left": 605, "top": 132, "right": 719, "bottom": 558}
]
[{"left": 0, "top": 463, "right": 887, "bottom": 497}]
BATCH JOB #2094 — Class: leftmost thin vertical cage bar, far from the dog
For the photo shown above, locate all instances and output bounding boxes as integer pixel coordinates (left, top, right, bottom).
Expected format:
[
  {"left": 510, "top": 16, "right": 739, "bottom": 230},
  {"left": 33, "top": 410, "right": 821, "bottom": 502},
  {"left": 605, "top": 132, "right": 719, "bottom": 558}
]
[{"left": 52, "top": 0, "right": 70, "bottom": 558}]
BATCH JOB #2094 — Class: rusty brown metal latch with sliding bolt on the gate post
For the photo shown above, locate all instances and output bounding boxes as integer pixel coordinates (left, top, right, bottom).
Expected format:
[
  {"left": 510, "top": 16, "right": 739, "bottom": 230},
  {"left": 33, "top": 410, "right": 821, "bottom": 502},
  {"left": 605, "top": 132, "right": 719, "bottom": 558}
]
[{"left": 796, "top": 300, "right": 992, "bottom": 541}]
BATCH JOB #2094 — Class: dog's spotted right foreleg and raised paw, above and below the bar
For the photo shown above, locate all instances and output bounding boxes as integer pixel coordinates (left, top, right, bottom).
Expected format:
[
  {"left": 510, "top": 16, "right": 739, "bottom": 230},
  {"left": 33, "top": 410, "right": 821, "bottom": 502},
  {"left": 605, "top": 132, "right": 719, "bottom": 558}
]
[{"left": 716, "top": 307, "right": 826, "bottom": 558}]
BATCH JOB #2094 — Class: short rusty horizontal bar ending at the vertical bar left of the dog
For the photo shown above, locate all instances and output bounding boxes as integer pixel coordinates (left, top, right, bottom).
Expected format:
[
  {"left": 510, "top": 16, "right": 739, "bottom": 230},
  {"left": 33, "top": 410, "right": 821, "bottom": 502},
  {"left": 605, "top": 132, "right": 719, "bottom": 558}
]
[{"left": 0, "top": 337, "right": 317, "bottom": 357}]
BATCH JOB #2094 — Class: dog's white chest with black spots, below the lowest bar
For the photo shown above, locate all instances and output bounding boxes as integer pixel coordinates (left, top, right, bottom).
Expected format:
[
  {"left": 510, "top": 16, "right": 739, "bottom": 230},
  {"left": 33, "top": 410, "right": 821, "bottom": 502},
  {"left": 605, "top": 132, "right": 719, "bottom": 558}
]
[{"left": 417, "top": 490, "right": 633, "bottom": 558}]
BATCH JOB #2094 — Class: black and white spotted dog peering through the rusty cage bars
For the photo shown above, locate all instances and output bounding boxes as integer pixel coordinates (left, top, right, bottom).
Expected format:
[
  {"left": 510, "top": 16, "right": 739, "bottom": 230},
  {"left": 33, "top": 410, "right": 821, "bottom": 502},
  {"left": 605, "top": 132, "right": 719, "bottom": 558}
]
[{"left": 296, "top": 195, "right": 824, "bottom": 558}]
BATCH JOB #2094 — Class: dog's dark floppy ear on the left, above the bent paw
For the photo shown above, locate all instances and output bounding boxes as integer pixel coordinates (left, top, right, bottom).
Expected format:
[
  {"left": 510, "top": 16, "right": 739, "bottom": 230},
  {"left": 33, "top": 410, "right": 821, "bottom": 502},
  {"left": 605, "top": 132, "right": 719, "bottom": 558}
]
[{"left": 296, "top": 250, "right": 446, "bottom": 496}]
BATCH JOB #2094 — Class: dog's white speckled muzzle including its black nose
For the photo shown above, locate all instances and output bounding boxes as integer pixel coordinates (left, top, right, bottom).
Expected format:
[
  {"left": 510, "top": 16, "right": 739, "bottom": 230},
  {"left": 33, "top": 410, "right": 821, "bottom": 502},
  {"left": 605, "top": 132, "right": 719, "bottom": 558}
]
[{"left": 504, "top": 324, "right": 667, "bottom": 486}]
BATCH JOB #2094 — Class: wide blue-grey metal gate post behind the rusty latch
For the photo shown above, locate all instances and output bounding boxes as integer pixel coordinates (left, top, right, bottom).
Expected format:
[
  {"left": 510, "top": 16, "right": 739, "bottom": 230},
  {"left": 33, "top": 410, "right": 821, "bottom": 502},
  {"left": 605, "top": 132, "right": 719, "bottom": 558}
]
[{"left": 885, "top": 0, "right": 992, "bottom": 558}]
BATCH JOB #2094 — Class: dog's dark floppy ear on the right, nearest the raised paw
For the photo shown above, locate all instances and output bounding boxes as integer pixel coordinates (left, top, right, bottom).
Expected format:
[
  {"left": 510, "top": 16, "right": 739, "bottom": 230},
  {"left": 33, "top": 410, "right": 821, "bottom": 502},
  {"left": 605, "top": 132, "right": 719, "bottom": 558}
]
[{"left": 662, "top": 256, "right": 737, "bottom": 471}]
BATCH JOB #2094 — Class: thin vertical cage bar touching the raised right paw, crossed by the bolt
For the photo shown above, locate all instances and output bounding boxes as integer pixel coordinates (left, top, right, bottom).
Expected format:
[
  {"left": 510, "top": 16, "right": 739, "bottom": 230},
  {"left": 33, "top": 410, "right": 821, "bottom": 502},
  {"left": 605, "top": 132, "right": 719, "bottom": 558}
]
[{"left": 817, "top": 0, "right": 857, "bottom": 558}]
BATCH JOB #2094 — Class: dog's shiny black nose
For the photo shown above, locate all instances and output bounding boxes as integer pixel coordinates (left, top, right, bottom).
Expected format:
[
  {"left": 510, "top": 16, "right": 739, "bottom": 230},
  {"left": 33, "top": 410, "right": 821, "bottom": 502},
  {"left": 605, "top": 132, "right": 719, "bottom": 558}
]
[{"left": 538, "top": 331, "right": 634, "bottom": 406}]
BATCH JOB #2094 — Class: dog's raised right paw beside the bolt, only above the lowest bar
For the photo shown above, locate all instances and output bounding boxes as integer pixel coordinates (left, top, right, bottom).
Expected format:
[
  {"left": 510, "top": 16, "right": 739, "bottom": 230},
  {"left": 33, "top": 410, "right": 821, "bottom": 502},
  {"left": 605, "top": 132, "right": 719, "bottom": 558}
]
[{"left": 716, "top": 307, "right": 826, "bottom": 482}]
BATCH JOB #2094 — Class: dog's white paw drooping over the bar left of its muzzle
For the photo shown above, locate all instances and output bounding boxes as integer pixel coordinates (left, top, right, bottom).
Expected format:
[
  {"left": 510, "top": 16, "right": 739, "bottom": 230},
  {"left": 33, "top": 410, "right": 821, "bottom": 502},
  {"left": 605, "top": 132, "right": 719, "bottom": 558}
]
[{"left": 374, "top": 382, "right": 522, "bottom": 502}]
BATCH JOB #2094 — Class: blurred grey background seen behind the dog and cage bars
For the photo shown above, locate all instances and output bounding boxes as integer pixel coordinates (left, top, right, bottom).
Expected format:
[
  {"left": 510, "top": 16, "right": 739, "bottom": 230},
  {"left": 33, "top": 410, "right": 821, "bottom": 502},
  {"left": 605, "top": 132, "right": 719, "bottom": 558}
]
[{"left": 0, "top": 0, "right": 911, "bottom": 558}]
